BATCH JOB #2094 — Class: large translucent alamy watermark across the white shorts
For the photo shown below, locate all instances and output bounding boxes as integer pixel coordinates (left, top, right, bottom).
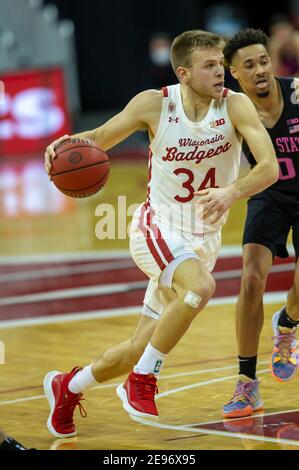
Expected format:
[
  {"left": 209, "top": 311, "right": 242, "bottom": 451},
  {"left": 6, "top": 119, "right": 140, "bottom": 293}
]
[{"left": 95, "top": 196, "right": 203, "bottom": 240}]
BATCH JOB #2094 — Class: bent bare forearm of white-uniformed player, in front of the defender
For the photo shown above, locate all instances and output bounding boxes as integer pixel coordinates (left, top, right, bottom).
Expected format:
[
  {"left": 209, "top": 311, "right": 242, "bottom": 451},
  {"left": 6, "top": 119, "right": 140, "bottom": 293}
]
[{"left": 232, "top": 160, "right": 279, "bottom": 199}]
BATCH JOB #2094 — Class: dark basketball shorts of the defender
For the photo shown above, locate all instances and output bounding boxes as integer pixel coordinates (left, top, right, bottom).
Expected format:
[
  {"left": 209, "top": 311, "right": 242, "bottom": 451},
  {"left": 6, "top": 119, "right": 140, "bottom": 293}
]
[{"left": 243, "top": 197, "right": 299, "bottom": 258}]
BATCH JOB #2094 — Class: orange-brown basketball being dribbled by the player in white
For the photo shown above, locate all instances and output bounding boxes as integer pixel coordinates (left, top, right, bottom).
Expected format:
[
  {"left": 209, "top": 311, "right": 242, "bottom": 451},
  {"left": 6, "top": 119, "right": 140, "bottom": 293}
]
[{"left": 51, "top": 139, "right": 110, "bottom": 197}]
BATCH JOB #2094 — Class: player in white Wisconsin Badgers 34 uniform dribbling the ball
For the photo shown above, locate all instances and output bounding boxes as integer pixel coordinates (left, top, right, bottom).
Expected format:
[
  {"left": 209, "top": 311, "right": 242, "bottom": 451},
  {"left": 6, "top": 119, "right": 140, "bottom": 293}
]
[{"left": 44, "top": 31, "right": 278, "bottom": 437}]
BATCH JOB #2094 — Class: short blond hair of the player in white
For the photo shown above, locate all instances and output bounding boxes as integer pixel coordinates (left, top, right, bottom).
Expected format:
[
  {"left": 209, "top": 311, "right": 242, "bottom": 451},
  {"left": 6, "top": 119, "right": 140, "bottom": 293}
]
[{"left": 170, "top": 29, "right": 224, "bottom": 75}]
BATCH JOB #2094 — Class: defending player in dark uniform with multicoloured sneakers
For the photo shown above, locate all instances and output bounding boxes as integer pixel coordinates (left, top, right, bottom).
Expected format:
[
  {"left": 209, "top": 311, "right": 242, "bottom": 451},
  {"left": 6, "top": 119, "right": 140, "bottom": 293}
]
[{"left": 223, "top": 29, "right": 299, "bottom": 418}]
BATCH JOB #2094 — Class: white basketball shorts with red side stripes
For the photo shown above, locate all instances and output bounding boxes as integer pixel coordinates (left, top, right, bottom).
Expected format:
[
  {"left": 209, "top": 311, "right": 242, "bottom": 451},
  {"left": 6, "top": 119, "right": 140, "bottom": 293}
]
[{"left": 130, "top": 206, "right": 221, "bottom": 318}]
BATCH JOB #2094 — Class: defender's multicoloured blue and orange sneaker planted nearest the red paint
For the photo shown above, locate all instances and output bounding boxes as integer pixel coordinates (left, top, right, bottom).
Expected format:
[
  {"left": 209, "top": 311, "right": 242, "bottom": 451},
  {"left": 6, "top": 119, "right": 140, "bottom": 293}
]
[{"left": 223, "top": 375, "right": 263, "bottom": 418}]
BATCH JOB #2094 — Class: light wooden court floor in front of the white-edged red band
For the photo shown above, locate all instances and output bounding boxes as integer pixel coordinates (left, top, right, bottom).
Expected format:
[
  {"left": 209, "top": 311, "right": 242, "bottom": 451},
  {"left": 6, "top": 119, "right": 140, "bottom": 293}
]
[{"left": 0, "top": 288, "right": 299, "bottom": 450}]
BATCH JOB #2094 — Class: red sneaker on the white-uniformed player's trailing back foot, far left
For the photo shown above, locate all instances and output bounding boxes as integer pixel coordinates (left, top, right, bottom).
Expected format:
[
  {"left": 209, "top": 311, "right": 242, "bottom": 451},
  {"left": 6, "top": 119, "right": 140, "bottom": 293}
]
[{"left": 44, "top": 367, "right": 86, "bottom": 437}]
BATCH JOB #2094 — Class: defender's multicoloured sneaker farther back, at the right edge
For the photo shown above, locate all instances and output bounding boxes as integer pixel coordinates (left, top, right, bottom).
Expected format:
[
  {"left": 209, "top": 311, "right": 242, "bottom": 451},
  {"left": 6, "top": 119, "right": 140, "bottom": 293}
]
[{"left": 271, "top": 311, "right": 299, "bottom": 382}]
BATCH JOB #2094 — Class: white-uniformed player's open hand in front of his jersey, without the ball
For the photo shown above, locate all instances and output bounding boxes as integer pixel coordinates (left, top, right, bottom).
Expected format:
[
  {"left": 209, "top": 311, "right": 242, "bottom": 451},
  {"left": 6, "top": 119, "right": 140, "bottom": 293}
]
[{"left": 194, "top": 186, "right": 235, "bottom": 224}]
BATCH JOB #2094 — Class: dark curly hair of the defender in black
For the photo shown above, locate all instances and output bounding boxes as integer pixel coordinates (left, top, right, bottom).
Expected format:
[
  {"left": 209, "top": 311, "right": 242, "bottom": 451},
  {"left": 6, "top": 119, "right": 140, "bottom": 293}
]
[{"left": 223, "top": 28, "right": 269, "bottom": 67}]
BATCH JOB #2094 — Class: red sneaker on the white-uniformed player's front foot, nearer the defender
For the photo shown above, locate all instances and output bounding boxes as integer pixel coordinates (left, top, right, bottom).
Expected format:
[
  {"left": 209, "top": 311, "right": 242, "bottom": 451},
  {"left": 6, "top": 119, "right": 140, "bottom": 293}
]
[{"left": 116, "top": 372, "right": 158, "bottom": 418}]
